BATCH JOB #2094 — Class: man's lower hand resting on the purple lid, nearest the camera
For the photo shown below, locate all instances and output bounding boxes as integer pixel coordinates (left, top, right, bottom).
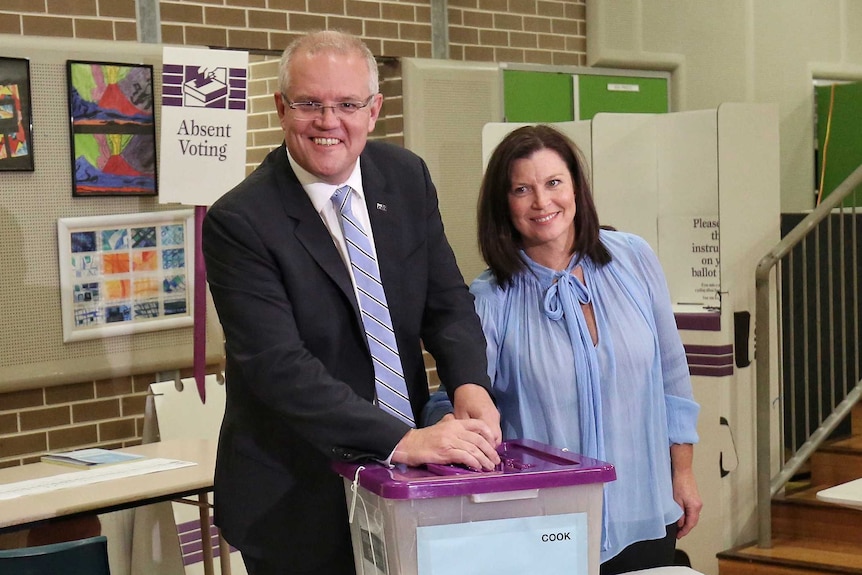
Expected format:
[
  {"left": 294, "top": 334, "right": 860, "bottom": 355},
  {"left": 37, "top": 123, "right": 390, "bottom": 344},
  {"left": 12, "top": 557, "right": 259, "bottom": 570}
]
[{"left": 392, "top": 418, "right": 500, "bottom": 471}]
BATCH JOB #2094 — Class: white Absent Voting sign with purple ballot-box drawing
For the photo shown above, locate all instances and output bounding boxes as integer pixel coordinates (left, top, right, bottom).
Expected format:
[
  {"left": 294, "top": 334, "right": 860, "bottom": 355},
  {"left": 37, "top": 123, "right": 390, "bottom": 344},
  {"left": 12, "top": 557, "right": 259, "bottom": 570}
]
[{"left": 159, "top": 47, "right": 248, "bottom": 206}]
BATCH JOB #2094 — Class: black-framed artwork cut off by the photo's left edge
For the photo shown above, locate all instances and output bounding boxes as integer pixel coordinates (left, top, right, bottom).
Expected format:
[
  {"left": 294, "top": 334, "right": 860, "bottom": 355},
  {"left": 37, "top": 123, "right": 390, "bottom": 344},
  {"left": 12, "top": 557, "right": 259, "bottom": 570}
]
[{"left": 0, "top": 57, "right": 34, "bottom": 172}]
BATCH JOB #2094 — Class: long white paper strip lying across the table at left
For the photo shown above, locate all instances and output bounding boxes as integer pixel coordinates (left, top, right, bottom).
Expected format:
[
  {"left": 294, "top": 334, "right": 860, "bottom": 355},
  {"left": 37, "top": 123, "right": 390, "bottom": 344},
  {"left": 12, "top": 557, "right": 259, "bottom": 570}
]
[{"left": 0, "top": 458, "right": 197, "bottom": 500}]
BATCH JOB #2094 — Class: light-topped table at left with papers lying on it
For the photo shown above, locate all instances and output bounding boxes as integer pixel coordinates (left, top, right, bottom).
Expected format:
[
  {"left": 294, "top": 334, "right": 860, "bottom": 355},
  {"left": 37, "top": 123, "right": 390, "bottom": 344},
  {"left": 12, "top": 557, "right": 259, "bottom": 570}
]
[{"left": 0, "top": 439, "right": 230, "bottom": 575}]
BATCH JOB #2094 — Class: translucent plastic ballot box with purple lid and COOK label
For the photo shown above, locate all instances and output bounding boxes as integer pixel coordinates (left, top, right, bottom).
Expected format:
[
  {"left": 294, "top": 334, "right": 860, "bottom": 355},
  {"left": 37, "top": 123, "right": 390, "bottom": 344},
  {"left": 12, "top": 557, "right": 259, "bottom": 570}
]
[{"left": 335, "top": 440, "right": 616, "bottom": 575}]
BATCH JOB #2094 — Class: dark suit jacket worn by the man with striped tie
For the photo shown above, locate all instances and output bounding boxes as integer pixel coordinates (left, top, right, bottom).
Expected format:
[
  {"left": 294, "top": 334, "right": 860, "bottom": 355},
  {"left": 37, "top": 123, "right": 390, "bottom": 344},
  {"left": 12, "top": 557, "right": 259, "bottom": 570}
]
[{"left": 203, "top": 142, "right": 490, "bottom": 569}]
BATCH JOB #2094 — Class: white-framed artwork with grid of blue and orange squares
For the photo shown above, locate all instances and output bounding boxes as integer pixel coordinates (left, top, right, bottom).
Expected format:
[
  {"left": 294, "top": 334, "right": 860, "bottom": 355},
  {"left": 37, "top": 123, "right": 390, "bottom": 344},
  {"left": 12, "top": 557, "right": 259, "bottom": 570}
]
[{"left": 57, "top": 209, "right": 194, "bottom": 342}]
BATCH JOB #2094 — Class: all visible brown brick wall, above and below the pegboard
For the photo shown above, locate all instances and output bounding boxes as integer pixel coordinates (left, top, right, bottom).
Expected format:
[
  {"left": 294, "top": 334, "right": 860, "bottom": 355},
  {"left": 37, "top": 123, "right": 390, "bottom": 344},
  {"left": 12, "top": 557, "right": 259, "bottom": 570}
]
[{"left": 0, "top": 0, "right": 586, "bottom": 467}]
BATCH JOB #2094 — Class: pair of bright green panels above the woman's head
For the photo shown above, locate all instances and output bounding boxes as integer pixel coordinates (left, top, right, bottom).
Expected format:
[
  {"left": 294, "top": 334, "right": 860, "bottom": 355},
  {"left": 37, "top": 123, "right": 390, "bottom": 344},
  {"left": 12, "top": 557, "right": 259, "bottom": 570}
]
[{"left": 503, "top": 70, "right": 669, "bottom": 122}]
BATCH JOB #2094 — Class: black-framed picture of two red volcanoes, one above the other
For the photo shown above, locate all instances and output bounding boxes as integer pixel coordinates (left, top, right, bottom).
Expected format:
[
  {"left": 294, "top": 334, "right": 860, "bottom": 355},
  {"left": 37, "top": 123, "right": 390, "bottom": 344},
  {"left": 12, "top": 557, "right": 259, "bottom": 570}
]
[{"left": 66, "top": 60, "right": 158, "bottom": 196}]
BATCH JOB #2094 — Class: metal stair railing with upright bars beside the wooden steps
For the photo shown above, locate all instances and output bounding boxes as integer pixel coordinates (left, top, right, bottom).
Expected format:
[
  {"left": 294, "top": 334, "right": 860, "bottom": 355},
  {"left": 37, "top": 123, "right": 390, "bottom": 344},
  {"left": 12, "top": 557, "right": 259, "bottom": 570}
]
[{"left": 755, "top": 165, "right": 862, "bottom": 548}]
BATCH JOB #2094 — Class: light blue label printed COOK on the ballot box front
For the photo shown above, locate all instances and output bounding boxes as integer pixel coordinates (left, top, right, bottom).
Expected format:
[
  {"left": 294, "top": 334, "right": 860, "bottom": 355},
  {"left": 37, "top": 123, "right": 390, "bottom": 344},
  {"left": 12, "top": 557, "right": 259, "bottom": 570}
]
[{"left": 416, "top": 513, "right": 588, "bottom": 575}]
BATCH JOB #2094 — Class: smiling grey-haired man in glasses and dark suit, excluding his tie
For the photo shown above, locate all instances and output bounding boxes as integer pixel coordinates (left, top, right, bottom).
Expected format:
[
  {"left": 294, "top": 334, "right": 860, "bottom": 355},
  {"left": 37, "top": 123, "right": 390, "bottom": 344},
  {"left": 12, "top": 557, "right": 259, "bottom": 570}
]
[{"left": 203, "top": 32, "right": 501, "bottom": 575}]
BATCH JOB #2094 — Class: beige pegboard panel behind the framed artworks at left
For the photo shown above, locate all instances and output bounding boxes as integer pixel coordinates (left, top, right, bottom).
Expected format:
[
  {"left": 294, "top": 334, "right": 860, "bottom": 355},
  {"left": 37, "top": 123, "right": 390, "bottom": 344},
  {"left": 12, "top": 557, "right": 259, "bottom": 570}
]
[{"left": 0, "top": 38, "right": 222, "bottom": 391}]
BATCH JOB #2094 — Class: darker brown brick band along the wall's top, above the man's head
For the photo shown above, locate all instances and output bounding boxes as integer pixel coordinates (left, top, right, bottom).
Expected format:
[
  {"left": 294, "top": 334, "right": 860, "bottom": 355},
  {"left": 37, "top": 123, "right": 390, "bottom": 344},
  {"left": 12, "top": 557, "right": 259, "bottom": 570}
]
[{"left": 0, "top": 0, "right": 586, "bottom": 66}]
